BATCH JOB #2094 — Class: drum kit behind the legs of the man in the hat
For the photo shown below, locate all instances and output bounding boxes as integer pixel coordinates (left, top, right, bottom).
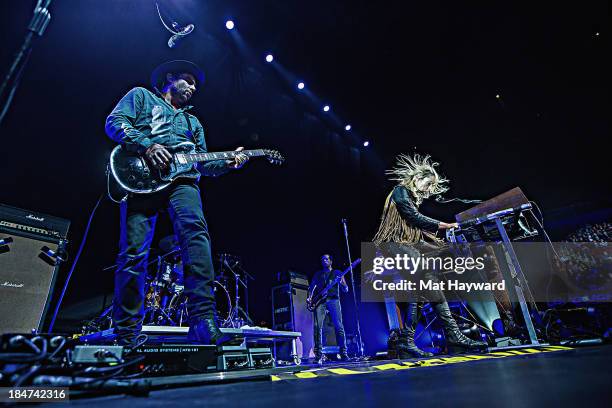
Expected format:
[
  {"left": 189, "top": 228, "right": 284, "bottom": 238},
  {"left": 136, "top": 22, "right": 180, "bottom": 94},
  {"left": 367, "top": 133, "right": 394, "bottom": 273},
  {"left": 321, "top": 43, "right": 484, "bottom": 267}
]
[{"left": 83, "top": 235, "right": 254, "bottom": 332}]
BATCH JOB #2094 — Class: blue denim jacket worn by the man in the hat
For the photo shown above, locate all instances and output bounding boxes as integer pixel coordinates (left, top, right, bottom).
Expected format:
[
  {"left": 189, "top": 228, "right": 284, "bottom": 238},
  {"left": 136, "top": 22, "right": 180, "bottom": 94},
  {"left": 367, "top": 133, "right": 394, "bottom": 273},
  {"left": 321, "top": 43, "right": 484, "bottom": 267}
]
[{"left": 105, "top": 87, "right": 230, "bottom": 179}]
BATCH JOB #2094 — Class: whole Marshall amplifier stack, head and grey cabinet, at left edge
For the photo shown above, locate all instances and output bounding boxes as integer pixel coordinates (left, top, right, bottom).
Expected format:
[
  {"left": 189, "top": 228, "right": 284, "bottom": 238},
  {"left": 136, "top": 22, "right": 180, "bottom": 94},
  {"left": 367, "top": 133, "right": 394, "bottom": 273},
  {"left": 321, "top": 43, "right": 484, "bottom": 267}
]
[{"left": 0, "top": 204, "right": 70, "bottom": 334}]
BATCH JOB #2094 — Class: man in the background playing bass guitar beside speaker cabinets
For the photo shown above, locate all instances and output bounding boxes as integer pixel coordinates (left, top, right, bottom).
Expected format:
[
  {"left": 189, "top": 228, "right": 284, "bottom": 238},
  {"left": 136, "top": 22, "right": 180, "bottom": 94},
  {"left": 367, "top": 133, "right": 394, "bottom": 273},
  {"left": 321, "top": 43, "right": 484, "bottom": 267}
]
[{"left": 308, "top": 254, "right": 349, "bottom": 362}]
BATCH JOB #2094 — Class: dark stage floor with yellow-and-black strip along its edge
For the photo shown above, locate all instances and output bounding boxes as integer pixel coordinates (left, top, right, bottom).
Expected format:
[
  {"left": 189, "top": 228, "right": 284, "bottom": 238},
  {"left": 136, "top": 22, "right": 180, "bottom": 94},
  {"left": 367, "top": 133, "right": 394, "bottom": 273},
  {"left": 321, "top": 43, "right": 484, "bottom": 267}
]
[{"left": 50, "top": 346, "right": 612, "bottom": 408}]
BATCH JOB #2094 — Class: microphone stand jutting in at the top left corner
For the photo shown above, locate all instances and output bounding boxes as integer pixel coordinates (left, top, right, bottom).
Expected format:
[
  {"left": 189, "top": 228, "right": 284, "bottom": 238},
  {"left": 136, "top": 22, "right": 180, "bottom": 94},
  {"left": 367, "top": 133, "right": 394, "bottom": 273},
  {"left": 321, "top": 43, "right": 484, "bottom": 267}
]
[{"left": 0, "top": 0, "right": 51, "bottom": 123}]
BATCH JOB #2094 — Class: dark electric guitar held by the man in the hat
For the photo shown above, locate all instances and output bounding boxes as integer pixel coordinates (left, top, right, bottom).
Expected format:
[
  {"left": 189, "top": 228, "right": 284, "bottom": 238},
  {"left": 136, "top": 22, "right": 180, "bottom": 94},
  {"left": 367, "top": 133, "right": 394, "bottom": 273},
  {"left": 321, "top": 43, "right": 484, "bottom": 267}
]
[{"left": 110, "top": 142, "right": 285, "bottom": 194}]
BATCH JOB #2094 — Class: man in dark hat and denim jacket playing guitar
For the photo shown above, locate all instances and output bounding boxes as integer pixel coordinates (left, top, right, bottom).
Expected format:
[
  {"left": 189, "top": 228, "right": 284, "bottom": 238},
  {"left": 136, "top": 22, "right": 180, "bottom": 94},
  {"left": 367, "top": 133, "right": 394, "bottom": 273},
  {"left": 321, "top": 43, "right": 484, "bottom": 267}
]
[{"left": 106, "top": 61, "right": 248, "bottom": 346}]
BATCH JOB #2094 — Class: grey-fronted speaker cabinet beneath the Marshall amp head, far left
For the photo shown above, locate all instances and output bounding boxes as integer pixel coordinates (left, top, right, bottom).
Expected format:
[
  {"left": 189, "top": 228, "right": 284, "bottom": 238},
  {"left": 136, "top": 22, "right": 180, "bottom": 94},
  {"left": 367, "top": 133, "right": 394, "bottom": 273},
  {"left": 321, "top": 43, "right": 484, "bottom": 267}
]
[{"left": 0, "top": 233, "right": 58, "bottom": 334}]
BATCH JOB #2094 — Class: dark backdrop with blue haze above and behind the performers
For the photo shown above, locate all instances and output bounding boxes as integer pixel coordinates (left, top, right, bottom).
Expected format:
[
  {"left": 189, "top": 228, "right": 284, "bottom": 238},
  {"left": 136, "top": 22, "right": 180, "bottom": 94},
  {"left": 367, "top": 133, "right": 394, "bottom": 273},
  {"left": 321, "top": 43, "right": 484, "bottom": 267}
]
[{"left": 0, "top": 0, "right": 610, "bottom": 348}]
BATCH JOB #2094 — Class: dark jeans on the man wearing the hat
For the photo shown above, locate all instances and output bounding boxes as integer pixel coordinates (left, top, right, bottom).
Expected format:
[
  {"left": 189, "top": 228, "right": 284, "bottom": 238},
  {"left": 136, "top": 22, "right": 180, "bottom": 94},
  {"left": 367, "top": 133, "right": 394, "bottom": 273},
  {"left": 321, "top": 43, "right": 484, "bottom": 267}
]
[{"left": 113, "top": 179, "right": 215, "bottom": 342}]
